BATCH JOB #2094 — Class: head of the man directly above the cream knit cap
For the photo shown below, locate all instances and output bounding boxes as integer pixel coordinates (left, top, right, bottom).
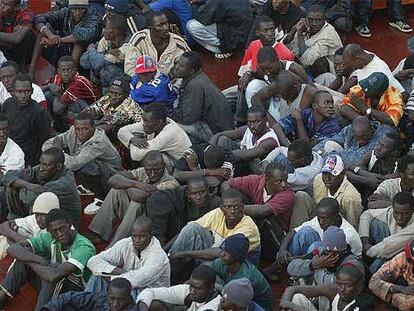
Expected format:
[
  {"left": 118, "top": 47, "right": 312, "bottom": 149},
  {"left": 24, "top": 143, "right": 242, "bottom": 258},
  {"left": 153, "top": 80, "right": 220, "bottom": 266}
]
[{"left": 39, "top": 147, "right": 65, "bottom": 181}]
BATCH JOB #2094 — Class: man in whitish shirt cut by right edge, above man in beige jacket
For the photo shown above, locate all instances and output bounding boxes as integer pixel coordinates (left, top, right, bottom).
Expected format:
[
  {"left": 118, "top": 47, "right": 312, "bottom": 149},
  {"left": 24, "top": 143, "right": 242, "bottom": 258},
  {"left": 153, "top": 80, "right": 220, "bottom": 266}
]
[{"left": 368, "top": 154, "right": 414, "bottom": 208}]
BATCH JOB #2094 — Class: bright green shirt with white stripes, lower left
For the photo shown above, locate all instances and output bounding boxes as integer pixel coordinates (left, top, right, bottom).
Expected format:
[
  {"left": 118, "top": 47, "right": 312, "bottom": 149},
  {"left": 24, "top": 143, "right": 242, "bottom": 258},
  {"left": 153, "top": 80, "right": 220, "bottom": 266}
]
[{"left": 29, "top": 232, "right": 96, "bottom": 287}]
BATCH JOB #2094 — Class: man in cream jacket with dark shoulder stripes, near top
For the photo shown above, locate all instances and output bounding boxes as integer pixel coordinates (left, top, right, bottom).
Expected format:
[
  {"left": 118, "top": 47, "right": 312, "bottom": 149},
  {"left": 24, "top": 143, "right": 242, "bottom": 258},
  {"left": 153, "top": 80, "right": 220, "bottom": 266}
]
[{"left": 124, "top": 12, "right": 190, "bottom": 77}]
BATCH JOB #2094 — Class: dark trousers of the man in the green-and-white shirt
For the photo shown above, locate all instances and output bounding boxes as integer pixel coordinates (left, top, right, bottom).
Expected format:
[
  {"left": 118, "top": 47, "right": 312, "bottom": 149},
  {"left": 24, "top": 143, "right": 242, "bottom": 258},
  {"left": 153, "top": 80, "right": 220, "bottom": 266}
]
[{"left": 1, "top": 260, "right": 84, "bottom": 310}]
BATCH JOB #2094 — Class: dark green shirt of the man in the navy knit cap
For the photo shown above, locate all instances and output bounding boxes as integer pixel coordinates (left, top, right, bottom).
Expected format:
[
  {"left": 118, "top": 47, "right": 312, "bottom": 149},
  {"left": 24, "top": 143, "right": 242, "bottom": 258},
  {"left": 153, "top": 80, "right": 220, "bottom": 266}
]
[{"left": 211, "top": 258, "right": 272, "bottom": 311}]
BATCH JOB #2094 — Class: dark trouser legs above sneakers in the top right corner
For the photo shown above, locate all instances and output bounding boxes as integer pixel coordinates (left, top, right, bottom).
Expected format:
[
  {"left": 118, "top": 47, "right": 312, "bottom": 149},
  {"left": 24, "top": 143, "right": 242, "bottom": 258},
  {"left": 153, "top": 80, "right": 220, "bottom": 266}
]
[{"left": 354, "top": 0, "right": 405, "bottom": 26}]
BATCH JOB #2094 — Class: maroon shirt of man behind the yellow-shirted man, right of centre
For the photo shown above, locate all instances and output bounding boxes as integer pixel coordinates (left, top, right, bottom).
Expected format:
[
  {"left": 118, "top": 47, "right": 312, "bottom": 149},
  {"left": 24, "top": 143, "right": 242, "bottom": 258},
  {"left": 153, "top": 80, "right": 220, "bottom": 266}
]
[{"left": 229, "top": 175, "right": 295, "bottom": 232}]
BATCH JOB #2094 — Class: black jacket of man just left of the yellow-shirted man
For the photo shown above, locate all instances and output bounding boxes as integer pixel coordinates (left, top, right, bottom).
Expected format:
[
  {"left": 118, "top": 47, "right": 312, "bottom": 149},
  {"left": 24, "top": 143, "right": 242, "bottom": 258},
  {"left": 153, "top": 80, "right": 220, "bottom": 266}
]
[{"left": 147, "top": 186, "right": 220, "bottom": 244}]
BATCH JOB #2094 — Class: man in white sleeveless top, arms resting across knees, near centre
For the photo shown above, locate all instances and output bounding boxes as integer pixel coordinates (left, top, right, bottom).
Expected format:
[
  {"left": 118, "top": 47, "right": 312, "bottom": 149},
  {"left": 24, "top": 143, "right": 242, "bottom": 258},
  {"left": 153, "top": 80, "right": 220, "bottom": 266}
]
[{"left": 210, "top": 106, "right": 279, "bottom": 173}]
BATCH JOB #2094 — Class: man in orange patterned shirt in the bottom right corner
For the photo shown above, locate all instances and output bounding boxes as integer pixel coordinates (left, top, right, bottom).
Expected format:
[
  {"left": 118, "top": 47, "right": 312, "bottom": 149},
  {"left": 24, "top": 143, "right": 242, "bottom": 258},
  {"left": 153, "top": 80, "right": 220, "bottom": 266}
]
[{"left": 369, "top": 239, "right": 414, "bottom": 311}]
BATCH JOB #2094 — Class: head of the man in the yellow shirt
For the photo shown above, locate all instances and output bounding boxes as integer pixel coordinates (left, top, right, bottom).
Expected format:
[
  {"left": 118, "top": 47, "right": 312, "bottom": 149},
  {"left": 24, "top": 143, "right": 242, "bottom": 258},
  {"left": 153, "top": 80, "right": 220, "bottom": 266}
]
[{"left": 220, "top": 188, "right": 244, "bottom": 228}]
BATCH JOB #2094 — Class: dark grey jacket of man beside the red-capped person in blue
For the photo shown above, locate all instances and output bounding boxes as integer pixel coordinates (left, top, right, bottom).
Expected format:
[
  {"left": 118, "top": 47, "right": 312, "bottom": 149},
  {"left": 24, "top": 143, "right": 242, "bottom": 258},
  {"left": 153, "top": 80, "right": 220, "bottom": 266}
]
[{"left": 171, "top": 70, "right": 234, "bottom": 134}]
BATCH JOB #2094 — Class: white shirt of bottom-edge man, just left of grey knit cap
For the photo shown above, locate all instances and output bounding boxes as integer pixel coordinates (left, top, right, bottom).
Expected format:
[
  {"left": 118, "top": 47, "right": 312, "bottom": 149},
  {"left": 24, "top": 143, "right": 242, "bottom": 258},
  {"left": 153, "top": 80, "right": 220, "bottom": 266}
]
[{"left": 137, "top": 284, "right": 221, "bottom": 311}]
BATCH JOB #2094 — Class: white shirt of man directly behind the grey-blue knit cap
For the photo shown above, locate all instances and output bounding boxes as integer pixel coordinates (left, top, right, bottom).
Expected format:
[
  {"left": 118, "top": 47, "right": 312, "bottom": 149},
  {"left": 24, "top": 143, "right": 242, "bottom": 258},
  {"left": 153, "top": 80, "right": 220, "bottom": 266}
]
[{"left": 293, "top": 217, "right": 362, "bottom": 256}]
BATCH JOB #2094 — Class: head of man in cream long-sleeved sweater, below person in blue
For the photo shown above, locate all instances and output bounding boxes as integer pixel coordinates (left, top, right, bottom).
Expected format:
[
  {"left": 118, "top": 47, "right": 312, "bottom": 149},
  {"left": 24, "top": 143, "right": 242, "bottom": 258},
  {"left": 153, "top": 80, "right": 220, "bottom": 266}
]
[{"left": 142, "top": 103, "right": 168, "bottom": 135}]
